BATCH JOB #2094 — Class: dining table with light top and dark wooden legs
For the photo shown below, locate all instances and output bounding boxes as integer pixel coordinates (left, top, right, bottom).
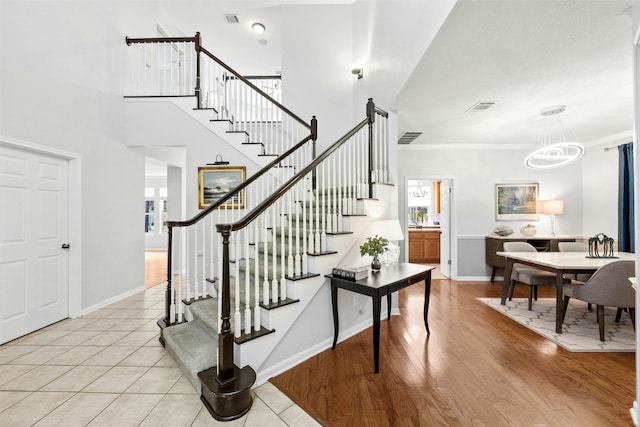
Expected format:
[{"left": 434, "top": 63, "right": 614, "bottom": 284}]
[{"left": 497, "top": 252, "right": 636, "bottom": 334}]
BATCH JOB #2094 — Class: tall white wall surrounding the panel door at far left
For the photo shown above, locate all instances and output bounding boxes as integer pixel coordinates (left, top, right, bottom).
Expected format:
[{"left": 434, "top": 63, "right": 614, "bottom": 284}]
[{"left": 0, "top": 0, "right": 155, "bottom": 311}]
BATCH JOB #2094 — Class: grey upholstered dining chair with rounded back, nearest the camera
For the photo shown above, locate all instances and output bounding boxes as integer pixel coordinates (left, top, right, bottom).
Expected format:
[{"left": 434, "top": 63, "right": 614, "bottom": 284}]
[{"left": 562, "top": 261, "right": 636, "bottom": 341}]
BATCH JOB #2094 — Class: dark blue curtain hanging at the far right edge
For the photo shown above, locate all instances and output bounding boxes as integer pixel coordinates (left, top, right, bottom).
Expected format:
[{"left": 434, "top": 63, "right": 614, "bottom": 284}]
[{"left": 618, "top": 142, "right": 635, "bottom": 252}]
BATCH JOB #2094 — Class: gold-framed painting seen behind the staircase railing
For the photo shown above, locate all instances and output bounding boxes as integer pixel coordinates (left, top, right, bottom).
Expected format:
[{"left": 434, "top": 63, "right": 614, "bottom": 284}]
[{"left": 198, "top": 166, "right": 247, "bottom": 209}]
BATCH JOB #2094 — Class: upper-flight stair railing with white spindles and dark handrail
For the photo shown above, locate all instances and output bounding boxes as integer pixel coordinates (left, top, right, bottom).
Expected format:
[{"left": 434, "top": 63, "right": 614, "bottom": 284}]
[{"left": 125, "top": 33, "right": 310, "bottom": 160}]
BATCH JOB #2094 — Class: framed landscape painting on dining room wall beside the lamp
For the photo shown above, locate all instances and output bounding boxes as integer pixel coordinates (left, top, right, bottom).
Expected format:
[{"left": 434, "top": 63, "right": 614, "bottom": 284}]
[{"left": 496, "top": 184, "right": 539, "bottom": 221}]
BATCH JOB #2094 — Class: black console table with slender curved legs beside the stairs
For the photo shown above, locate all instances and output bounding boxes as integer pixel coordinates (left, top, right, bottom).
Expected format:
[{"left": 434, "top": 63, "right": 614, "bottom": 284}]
[{"left": 326, "top": 263, "right": 433, "bottom": 373}]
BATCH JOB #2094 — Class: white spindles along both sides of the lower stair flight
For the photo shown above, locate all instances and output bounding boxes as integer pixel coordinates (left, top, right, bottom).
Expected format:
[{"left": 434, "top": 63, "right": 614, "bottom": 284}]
[{"left": 156, "top": 78, "right": 388, "bottom": 386}]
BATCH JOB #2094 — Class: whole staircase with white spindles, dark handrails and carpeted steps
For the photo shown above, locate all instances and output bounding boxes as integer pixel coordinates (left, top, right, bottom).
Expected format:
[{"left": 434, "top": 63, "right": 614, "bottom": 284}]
[{"left": 127, "top": 34, "right": 389, "bottom": 420}]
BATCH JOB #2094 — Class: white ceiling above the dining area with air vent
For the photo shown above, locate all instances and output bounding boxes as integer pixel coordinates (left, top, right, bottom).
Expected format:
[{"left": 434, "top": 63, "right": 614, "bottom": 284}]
[{"left": 392, "top": 0, "right": 633, "bottom": 146}]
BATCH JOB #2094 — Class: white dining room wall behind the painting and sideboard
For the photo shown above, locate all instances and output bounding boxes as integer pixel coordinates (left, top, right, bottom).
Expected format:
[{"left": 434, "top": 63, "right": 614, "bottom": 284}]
[{"left": 398, "top": 146, "right": 583, "bottom": 280}]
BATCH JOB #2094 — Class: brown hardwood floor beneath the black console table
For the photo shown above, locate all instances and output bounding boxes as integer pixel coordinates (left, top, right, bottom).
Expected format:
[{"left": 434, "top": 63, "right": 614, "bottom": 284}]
[{"left": 270, "top": 279, "right": 635, "bottom": 427}]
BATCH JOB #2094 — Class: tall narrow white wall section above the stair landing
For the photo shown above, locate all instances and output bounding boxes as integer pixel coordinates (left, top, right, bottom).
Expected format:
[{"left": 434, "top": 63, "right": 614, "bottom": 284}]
[{"left": 282, "top": 5, "right": 358, "bottom": 152}]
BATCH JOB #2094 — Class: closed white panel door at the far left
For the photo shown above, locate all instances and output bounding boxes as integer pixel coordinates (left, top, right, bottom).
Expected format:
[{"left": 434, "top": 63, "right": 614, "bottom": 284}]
[{"left": 0, "top": 147, "right": 69, "bottom": 344}]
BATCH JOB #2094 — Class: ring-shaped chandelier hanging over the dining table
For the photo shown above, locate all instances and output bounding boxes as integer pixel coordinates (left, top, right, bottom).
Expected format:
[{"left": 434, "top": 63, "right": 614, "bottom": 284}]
[{"left": 524, "top": 105, "right": 584, "bottom": 169}]
